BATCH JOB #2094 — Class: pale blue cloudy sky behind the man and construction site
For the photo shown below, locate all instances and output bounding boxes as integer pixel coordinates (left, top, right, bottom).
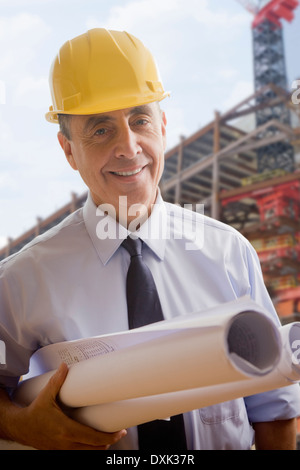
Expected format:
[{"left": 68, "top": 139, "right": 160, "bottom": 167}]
[{"left": 0, "top": 0, "right": 300, "bottom": 247}]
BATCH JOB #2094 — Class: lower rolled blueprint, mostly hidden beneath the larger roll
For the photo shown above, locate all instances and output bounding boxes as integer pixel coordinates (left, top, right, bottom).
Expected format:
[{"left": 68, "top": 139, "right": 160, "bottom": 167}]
[{"left": 69, "top": 322, "right": 300, "bottom": 432}]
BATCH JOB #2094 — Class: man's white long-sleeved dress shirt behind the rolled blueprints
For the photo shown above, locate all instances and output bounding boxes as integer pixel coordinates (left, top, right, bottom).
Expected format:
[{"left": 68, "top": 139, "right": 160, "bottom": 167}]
[{"left": 0, "top": 195, "right": 300, "bottom": 450}]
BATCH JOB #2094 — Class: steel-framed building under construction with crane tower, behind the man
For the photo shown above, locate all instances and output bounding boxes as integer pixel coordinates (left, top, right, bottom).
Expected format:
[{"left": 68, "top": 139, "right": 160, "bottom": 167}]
[{"left": 0, "top": 0, "right": 300, "bottom": 323}]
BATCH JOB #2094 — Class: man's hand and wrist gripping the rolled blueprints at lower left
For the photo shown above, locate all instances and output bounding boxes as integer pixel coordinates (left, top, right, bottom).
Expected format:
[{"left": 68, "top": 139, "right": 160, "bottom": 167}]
[{"left": 0, "top": 364, "right": 126, "bottom": 450}]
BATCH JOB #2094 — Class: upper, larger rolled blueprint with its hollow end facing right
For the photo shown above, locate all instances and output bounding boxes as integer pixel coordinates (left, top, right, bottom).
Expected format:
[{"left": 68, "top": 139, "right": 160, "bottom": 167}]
[{"left": 15, "top": 300, "right": 282, "bottom": 415}]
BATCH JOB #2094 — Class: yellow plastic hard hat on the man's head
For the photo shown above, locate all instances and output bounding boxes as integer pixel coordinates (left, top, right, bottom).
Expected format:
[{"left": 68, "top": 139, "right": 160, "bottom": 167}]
[{"left": 46, "top": 28, "right": 169, "bottom": 123}]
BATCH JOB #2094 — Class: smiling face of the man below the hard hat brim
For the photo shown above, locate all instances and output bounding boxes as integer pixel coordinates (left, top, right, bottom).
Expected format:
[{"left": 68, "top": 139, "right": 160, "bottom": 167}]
[{"left": 58, "top": 103, "right": 166, "bottom": 228}]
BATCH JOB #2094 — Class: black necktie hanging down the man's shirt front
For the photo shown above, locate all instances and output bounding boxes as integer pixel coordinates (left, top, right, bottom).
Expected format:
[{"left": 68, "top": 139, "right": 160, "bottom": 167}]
[{"left": 122, "top": 236, "right": 187, "bottom": 452}]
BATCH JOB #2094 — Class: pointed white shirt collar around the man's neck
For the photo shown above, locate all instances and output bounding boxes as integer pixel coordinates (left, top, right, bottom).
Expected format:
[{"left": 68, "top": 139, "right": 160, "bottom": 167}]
[{"left": 83, "top": 192, "right": 167, "bottom": 265}]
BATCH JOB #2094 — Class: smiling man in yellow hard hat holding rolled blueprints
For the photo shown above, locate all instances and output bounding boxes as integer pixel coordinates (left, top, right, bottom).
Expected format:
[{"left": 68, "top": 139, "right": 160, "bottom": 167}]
[{"left": 0, "top": 29, "right": 299, "bottom": 450}]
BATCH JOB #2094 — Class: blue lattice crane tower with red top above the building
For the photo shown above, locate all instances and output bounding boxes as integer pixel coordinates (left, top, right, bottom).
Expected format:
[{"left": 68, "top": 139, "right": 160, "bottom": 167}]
[{"left": 236, "top": 0, "right": 299, "bottom": 173}]
